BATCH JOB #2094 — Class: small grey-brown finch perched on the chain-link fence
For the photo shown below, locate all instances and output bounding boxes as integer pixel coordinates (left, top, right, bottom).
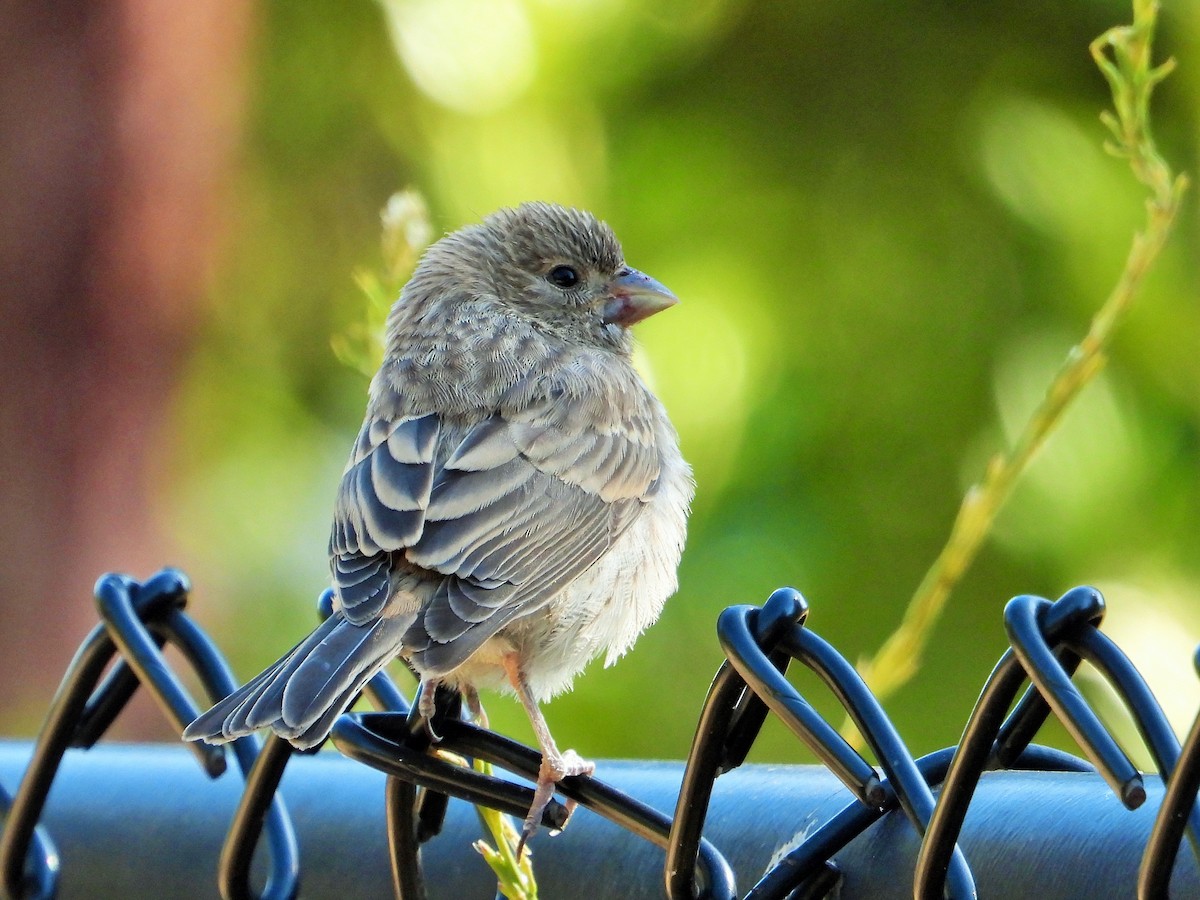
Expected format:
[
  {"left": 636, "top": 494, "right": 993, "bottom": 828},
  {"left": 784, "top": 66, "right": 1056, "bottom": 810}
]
[{"left": 184, "top": 202, "right": 695, "bottom": 847}]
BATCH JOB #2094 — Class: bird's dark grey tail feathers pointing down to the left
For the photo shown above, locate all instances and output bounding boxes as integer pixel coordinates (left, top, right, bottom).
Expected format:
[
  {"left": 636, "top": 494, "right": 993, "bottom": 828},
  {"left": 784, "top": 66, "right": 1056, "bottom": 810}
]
[{"left": 184, "top": 613, "right": 412, "bottom": 750}]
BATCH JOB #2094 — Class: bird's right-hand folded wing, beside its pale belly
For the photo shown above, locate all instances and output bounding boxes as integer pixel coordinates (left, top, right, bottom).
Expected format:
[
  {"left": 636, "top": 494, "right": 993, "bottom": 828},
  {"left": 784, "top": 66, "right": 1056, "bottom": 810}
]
[{"left": 404, "top": 397, "right": 659, "bottom": 674}]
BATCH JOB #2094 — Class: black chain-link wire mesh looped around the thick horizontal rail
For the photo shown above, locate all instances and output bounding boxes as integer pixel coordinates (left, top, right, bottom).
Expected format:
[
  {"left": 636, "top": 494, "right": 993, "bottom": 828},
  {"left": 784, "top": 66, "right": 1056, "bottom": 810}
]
[{"left": 0, "top": 569, "right": 1200, "bottom": 900}]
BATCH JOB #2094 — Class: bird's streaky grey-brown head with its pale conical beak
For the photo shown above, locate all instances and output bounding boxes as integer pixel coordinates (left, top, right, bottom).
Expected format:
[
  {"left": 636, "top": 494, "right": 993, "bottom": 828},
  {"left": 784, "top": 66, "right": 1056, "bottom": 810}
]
[{"left": 420, "top": 203, "right": 679, "bottom": 353}]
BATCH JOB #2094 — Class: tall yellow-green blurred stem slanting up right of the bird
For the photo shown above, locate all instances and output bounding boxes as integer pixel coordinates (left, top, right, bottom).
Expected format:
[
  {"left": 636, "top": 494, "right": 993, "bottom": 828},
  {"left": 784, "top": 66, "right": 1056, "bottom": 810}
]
[{"left": 842, "top": 0, "right": 1187, "bottom": 733}]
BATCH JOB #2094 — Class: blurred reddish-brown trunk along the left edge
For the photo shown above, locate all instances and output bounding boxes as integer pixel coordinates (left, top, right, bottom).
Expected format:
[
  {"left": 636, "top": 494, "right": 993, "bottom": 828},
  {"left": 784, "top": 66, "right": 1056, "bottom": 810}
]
[{"left": 0, "top": 0, "right": 250, "bottom": 733}]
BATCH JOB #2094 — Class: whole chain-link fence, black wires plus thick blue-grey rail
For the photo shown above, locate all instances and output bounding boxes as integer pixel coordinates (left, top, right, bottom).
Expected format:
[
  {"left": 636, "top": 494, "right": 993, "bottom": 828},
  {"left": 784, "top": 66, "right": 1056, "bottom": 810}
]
[{"left": 0, "top": 570, "right": 1200, "bottom": 900}]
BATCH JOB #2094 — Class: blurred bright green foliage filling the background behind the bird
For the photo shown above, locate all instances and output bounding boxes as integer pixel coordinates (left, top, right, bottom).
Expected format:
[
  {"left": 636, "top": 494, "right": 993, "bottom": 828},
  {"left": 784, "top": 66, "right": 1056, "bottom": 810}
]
[{"left": 2, "top": 0, "right": 1200, "bottom": 761}]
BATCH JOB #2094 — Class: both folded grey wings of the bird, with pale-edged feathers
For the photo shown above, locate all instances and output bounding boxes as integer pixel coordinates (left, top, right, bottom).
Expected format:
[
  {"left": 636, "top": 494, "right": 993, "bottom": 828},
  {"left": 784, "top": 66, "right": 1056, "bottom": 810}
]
[{"left": 331, "top": 381, "right": 659, "bottom": 674}]
